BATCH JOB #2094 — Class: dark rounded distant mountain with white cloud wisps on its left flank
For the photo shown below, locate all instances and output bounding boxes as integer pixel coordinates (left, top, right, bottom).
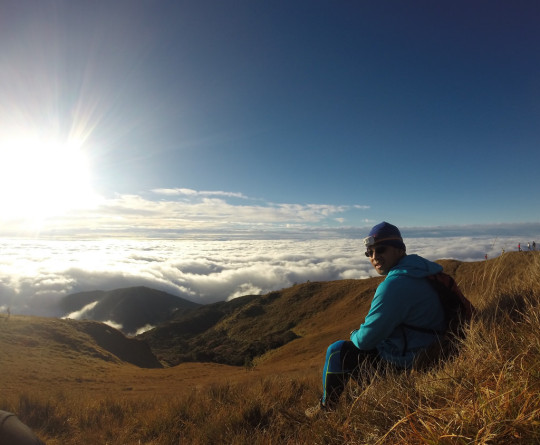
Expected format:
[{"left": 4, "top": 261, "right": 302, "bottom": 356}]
[{"left": 60, "top": 286, "right": 201, "bottom": 334}]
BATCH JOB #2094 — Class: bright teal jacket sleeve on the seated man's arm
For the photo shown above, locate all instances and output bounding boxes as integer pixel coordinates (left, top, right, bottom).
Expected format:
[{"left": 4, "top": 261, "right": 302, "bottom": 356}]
[{"left": 351, "top": 278, "right": 406, "bottom": 350}]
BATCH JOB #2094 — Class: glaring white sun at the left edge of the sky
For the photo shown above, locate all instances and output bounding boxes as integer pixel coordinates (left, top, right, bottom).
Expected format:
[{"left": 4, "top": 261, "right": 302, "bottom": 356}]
[{"left": 0, "top": 130, "right": 97, "bottom": 224}]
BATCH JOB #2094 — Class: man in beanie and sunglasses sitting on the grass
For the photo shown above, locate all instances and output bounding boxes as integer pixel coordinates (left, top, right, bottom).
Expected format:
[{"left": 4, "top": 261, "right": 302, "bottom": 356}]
[{"left": 306, "top": 222, "right": 445, "bottom": 417}]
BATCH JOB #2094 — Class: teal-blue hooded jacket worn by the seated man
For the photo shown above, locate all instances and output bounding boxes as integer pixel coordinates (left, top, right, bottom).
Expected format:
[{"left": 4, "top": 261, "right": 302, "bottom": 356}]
[{"left": 351, "top": 255, "right": 444, "bottom": 368}]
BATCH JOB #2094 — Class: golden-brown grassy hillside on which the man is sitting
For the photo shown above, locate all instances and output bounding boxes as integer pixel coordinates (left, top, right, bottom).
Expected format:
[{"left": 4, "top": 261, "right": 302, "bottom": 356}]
[{"left": 0, "top": 252, "right": 540, "bottom": 445}]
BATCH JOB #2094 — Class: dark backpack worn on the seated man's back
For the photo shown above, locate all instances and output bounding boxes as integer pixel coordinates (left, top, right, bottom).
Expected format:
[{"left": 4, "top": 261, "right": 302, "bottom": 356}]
[{"left": 401, "top": 272, "right": 476, "bottom": 364}]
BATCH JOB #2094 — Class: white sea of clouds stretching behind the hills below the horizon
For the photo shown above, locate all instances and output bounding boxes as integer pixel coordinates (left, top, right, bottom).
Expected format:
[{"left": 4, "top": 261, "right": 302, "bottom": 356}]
[{"left": 0, "top": 234, "right": 533, "bottom": 316}]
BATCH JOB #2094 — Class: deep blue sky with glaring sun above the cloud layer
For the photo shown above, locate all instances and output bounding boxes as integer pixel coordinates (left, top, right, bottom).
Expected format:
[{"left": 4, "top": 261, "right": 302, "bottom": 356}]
[{"left": 0, "top": 0, "right": 540, "bottom": 237}]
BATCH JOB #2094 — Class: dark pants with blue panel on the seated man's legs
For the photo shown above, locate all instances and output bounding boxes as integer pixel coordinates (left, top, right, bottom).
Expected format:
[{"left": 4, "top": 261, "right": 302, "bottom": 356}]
[{"left": 321, "top": 340, "right": 382, "bottom": 407}]
